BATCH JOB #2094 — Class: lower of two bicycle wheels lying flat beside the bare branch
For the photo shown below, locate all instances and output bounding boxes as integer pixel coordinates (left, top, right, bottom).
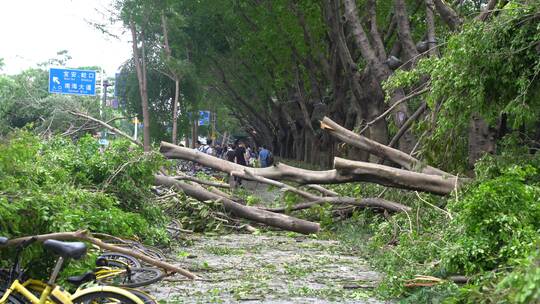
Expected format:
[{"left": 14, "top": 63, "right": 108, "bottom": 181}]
[{"left": 97, "top": 267, "right": 165, "bottom": 287}]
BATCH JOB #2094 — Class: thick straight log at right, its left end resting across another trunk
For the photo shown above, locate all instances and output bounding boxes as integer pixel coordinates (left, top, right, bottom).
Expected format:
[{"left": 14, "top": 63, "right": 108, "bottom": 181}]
[{"left": 334, "top": 157, "right": 461, "bottom": 195}]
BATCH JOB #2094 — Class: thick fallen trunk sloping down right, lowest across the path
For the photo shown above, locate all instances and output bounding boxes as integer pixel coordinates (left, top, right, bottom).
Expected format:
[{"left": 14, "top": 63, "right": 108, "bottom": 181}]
[{"left": 155, "top": 175, "right": 320, "bottom": 234}]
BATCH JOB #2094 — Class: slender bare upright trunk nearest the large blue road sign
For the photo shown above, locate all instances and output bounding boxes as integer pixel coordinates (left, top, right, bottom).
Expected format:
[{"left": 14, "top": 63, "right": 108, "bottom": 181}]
[{"left": 129, "top": 21, "right": 151, "bottom": 151}]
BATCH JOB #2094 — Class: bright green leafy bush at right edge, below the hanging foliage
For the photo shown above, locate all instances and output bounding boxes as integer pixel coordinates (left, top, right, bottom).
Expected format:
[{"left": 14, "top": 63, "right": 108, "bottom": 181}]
[{"left": 445, "top": 165, "right": 540, "bottom": 274}]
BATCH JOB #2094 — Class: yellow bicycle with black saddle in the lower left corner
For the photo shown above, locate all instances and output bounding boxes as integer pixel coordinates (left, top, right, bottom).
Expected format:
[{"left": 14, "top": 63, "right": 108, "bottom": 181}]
[{"left": 0, "top": 237, "right": 144, "bottom": 304}]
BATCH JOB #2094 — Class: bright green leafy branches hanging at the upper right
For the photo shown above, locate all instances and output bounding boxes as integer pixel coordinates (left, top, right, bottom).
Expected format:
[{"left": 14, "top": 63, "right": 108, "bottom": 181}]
[{"left": 386, "top": 1, "right": 540, "bottom": 170}]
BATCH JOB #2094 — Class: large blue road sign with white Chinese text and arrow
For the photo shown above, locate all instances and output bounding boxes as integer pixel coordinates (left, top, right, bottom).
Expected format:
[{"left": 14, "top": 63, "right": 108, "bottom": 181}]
[{"left": 49, "top": 68, "right": 96, "bottom": 95}]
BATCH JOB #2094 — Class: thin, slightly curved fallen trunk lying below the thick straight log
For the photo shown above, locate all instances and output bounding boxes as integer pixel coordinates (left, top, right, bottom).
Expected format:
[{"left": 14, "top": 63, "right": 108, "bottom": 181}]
[{"left": 264, "top": 197, "right": 411, "bottom": 212}]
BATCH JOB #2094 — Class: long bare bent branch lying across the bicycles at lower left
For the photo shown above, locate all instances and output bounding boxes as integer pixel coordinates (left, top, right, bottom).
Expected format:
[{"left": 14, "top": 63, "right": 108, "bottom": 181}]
[{"left": 5, "top": 230, "right": 197, "bottom": 279}]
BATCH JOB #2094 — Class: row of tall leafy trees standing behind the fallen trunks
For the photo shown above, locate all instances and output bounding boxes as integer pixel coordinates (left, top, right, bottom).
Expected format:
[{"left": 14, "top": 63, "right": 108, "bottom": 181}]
[{"left": 117, "top": 0, "right": 537, "bottom": 171}]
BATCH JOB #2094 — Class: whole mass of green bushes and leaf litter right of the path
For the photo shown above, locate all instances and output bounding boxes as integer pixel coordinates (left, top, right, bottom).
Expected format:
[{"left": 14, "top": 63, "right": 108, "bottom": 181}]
[{"left": 336, "top": 151, "right": 540, "bottom": 303}]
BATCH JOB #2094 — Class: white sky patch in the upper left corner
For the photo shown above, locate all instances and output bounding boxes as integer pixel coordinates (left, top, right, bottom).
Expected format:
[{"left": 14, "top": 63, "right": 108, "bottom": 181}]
[{"left": 0, "top": 0, "right": 131, "bottom": 76}]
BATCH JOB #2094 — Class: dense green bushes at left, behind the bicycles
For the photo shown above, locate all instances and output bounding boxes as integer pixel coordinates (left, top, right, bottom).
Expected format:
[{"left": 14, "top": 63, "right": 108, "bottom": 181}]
[{"left": 0, "top": 131, "right": 168, "bottom": 276}]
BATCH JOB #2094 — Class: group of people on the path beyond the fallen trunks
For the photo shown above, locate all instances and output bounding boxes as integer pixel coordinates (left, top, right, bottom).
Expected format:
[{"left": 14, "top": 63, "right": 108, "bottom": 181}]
[{"left": 195, "top": 139, "right": 274, "bottom": 168}]
